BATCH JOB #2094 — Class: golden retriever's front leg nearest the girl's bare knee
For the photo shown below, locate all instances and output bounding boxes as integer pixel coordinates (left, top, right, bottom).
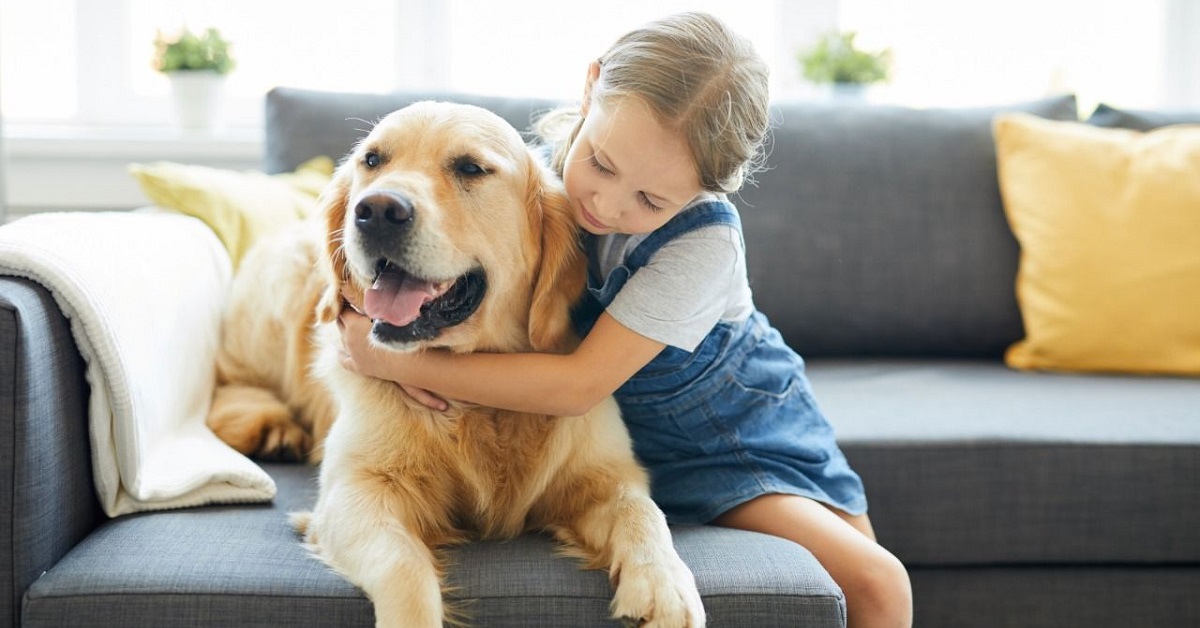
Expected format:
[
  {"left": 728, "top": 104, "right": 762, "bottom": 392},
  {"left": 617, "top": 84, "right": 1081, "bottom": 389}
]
[{"left": 569, "top": 485, "right": 704, "bottom": 628}]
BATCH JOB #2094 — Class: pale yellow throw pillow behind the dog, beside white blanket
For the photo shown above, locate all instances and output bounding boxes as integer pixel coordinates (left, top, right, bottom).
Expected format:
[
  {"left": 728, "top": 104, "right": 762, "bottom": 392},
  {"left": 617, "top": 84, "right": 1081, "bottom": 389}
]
[{"left": 130, "top": 157, "right": 334, "bottom": 268}]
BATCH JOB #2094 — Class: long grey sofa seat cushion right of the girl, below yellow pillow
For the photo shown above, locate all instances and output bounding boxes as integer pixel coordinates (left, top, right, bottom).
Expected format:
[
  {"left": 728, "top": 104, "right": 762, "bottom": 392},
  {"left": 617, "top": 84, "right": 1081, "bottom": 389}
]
[{"left": 809, "top": 360, "right": 1200, "bottom": 566}]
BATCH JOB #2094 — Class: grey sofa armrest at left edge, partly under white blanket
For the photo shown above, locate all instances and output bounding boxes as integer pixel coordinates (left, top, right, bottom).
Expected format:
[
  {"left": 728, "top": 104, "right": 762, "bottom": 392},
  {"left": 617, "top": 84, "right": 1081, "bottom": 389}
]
[{"left": 0, "top": 276, "right": 104, "bottom": 627}]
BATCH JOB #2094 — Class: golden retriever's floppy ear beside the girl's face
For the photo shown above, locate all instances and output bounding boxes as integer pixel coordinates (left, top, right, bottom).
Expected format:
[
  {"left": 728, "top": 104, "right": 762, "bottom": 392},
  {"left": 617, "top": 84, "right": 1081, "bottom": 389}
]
[{"left": 529, "top": 159, "right": 587, "bottom": 353}]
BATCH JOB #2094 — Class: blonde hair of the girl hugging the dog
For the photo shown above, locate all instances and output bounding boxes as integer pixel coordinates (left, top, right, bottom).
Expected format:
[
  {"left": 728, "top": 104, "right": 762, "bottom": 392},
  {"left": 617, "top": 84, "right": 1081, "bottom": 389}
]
[{"left": 535, "top": 12, "right": 770, "bottom": 193}]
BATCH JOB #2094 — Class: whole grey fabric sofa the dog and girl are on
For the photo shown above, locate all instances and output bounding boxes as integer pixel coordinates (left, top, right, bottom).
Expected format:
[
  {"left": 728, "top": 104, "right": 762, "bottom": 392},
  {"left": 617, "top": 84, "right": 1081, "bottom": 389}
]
[{"left": 7, "top": 89, "right": 1200, "bottom": 628}]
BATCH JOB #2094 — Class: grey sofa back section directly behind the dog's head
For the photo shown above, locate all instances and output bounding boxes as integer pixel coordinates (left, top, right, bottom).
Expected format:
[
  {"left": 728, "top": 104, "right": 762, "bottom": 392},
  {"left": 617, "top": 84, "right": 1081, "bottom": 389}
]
[{"left": 263, "top": 88, "right": 557, "bottom": 174}]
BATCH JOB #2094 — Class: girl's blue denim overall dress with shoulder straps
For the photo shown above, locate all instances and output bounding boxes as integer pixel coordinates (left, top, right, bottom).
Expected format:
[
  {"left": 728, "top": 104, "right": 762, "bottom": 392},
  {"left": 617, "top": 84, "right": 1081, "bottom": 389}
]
[{"left": 575, "top": 201, "right": 866, "bottom": 524}]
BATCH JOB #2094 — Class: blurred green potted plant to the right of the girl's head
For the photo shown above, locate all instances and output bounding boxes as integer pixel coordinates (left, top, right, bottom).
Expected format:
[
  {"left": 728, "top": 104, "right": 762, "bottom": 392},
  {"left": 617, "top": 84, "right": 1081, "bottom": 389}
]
[{"left": 798, "top": 31, "right": 892, "bottom": 97}]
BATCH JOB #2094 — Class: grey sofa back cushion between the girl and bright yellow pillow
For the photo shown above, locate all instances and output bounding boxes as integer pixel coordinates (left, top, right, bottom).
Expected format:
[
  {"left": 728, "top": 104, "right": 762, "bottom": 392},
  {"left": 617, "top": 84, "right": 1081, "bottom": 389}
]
[{"left": 736, "top": 96, "right": 1076, "bottom": 357}]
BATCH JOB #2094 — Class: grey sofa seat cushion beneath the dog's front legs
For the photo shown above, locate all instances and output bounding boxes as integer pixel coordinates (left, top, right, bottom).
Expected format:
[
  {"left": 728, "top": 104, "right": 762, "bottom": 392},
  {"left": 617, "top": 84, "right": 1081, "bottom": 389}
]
[{"left": 23, "top": 465, "right": 845, "bottom": 628}]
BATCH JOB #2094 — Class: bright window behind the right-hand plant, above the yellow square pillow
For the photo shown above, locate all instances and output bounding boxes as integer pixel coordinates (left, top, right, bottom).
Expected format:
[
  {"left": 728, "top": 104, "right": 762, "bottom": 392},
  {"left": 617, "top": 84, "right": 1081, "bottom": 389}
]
[{"left": 841, "top": 0, "right": 1180, "bottom": 115}]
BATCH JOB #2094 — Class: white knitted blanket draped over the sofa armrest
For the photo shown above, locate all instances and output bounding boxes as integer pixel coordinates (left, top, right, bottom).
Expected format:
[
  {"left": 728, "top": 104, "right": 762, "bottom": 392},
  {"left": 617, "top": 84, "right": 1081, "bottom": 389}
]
[{"left": 0, "top": 211, "right": 275, "bottom": 516}]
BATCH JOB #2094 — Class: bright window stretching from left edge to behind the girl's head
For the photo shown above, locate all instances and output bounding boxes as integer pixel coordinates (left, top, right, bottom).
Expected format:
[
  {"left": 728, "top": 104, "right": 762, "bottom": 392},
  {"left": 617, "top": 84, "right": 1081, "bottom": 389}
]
[{"left": 0, "top": 0, "right": 796, "bottom": 127}]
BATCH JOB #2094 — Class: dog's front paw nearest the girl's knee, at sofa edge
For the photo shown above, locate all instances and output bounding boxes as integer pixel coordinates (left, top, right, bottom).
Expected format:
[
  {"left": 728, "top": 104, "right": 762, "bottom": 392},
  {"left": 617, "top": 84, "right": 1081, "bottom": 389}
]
[{"left": 612, "top": 558, "right": 704, "bottom": 628}]
